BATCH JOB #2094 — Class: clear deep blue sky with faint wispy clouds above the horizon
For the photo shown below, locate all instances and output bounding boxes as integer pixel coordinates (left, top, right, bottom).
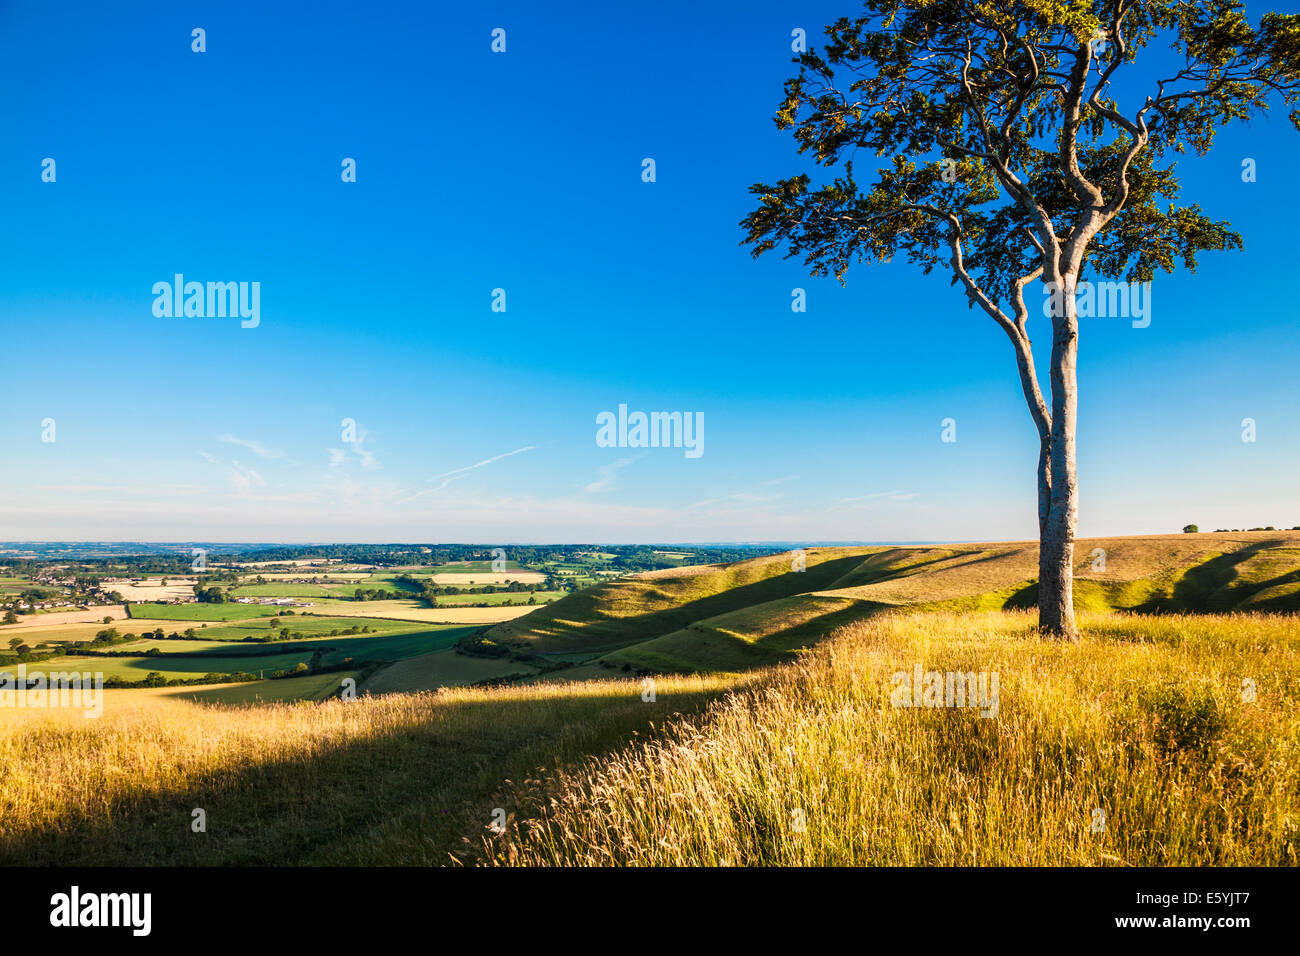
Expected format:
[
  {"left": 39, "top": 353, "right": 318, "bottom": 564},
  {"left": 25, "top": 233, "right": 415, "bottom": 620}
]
[{"left": 0, "top": 1, "right": 1300, "bottom": 542}]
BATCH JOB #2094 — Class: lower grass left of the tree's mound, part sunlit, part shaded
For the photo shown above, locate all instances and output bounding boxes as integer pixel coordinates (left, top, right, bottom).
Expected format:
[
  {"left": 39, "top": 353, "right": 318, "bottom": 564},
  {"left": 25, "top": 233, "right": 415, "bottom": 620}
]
[{"left": 0, "top": 678, "right": 729, "bottom": 865}]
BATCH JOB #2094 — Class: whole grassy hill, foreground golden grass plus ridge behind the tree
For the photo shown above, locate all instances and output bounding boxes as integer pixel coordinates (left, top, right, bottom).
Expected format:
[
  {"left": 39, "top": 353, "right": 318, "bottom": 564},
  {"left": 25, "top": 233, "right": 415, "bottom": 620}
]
[{"left": 0, "top": 532, "right": 1300, "bottom": 866}]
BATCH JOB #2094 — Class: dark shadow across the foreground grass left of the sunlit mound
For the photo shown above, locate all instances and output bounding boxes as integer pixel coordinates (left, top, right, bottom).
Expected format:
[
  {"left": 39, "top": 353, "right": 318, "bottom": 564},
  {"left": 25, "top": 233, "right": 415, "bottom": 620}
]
[{"left": 0, "top": 682, "right": 725, "bottom": 866}]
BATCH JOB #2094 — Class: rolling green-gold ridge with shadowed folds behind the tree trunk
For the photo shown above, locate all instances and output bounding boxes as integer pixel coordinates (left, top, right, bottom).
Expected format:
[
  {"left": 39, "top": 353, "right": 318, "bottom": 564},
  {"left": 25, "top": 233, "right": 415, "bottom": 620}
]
[{"left": 488, "top": 531, "right": 1300, "bottom": 680}]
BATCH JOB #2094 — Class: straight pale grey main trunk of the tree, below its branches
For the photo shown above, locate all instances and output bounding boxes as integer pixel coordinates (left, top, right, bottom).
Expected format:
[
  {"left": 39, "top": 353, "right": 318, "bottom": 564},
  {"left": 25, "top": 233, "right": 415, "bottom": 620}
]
[{"left": 1039, "top": 286, "right": 1079, "bottom": 640}]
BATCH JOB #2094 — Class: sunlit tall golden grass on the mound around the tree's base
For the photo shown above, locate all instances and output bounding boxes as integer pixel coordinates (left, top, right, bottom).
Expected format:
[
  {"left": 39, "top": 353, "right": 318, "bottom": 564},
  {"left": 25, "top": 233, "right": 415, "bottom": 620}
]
[{"left": 484, "top": 613, "right": 1300, "bottom": 866}]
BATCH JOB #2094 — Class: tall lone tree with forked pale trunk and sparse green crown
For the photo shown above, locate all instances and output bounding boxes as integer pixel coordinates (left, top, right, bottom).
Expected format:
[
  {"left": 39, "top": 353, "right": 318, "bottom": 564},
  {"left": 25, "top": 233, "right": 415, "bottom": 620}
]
[{"left": 741, "top": 0, "right": 1300, "bottom": 639}]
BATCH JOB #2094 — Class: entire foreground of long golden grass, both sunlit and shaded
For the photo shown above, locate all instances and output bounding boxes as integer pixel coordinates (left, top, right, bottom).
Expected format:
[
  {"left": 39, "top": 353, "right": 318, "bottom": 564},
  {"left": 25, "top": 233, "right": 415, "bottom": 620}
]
[{"left": 0, "top": 571, "right": 1300, "bottom": 866}]
